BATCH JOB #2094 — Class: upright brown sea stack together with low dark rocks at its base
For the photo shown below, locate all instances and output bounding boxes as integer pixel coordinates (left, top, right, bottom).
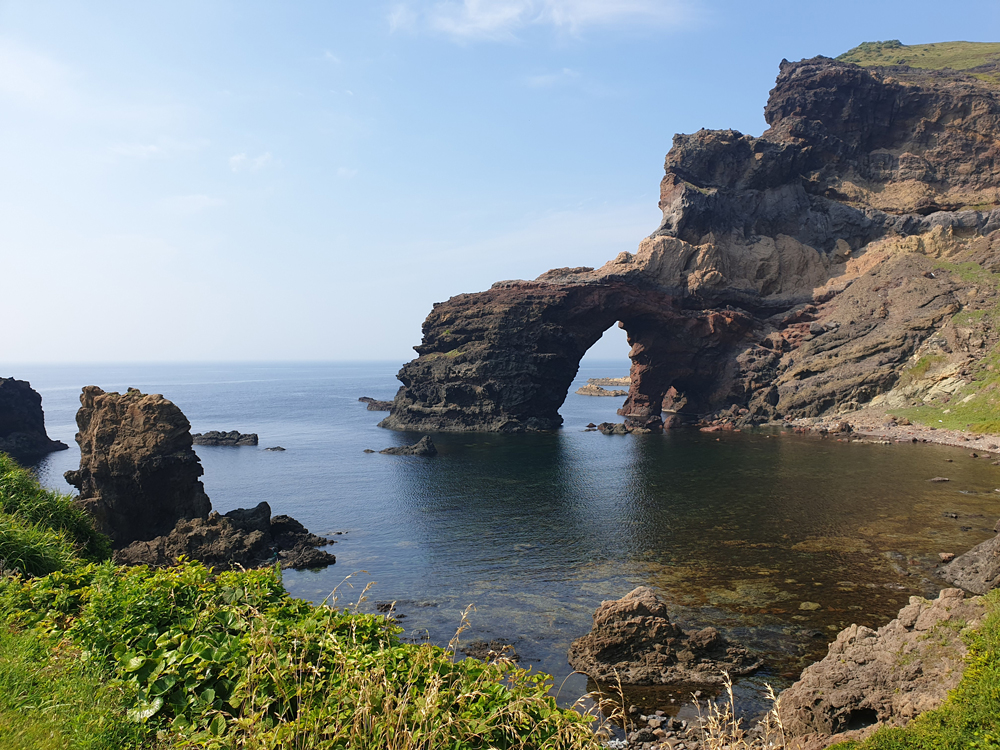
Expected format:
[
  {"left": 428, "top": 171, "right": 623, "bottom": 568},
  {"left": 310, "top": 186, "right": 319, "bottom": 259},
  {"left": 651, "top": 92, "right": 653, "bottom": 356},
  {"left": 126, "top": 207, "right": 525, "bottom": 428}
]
[{"left": 66, "top": 386, "right": 335, "bottom": 568}]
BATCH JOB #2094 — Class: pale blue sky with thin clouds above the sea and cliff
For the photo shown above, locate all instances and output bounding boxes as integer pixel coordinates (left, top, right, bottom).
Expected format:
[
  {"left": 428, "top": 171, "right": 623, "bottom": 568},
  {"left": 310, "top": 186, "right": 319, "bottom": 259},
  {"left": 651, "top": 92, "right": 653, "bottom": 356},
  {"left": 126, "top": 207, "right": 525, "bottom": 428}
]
[{"left": 0, "top": 0, "right": 1000, "bottom": 364}]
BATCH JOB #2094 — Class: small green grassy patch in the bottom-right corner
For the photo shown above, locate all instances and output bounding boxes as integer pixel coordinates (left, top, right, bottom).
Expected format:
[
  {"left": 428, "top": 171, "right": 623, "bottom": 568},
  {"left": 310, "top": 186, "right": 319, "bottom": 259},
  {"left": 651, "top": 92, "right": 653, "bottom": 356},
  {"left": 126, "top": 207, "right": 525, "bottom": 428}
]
[{"left": 834, "top": 591, "right": 1000, "bottom": 750}]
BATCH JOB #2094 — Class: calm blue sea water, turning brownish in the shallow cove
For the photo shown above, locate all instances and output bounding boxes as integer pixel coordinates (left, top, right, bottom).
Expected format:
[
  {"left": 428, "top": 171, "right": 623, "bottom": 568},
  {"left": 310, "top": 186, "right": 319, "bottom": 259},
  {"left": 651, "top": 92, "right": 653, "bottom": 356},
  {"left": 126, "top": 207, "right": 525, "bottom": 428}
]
[{"left": 13, "top": 361, "right": 1000, "bottom": 710}]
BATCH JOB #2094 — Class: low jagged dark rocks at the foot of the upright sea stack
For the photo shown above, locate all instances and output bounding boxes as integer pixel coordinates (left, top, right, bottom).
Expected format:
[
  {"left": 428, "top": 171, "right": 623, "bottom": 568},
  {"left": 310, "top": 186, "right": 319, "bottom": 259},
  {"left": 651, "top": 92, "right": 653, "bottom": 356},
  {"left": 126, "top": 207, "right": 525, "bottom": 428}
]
[{"left": 115, "top": 502, "right": 336, "bottom": 570}]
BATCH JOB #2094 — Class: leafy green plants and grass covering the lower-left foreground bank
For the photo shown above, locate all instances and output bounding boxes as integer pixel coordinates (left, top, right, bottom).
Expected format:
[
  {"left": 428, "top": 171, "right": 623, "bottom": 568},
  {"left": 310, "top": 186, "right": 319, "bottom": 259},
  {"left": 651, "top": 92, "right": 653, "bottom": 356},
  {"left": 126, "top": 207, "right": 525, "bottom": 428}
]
[{"left": 0, "top": 458, "right": 598, "bottom": 750}]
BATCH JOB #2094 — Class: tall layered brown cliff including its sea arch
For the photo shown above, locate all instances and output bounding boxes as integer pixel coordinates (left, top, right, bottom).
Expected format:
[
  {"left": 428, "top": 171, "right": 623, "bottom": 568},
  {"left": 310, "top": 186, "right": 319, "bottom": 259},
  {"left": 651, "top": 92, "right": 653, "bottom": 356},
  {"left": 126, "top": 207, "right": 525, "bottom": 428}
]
[{"left": 382, "top": 58, "right": 1000, "bottom": 430}]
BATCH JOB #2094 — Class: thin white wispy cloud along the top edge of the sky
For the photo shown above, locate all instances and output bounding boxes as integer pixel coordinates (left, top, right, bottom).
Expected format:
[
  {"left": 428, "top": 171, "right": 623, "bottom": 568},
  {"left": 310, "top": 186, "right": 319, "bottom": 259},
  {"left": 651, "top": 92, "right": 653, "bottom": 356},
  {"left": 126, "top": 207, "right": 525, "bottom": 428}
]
[{"left": 389, "top": 0, "right": 691, "bottom": 40}]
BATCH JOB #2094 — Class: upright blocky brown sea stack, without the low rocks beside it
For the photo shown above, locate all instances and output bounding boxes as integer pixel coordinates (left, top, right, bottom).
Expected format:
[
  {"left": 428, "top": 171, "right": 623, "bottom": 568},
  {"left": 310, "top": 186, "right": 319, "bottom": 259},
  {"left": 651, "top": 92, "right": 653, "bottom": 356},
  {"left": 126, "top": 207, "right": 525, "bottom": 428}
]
[{"left": 66, "top": 385, "right": 212, "bottom": 548}]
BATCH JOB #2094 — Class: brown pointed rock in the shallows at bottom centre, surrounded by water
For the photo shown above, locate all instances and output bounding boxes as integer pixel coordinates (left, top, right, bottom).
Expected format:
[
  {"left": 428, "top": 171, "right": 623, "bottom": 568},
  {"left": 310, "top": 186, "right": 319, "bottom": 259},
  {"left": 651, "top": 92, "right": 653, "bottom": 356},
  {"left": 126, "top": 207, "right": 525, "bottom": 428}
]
[{"left": 569, "top": 586, "right": 760, "bottom": 685}]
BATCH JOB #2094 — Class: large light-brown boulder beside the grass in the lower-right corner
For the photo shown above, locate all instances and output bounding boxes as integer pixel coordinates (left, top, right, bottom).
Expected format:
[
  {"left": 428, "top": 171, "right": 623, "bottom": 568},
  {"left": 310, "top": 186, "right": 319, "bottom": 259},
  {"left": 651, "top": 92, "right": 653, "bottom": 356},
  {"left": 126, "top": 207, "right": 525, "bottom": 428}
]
[{"left": 780, "top": 589, "right": 985, "bottom": 750}]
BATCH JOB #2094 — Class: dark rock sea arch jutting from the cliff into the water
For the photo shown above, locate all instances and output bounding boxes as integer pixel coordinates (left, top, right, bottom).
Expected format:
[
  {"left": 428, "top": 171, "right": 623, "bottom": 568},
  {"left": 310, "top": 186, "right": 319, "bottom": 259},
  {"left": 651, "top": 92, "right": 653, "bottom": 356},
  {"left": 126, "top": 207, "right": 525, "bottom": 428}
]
[{"left": 382, "top": 281, "right": 751, "bottom": 432}]
